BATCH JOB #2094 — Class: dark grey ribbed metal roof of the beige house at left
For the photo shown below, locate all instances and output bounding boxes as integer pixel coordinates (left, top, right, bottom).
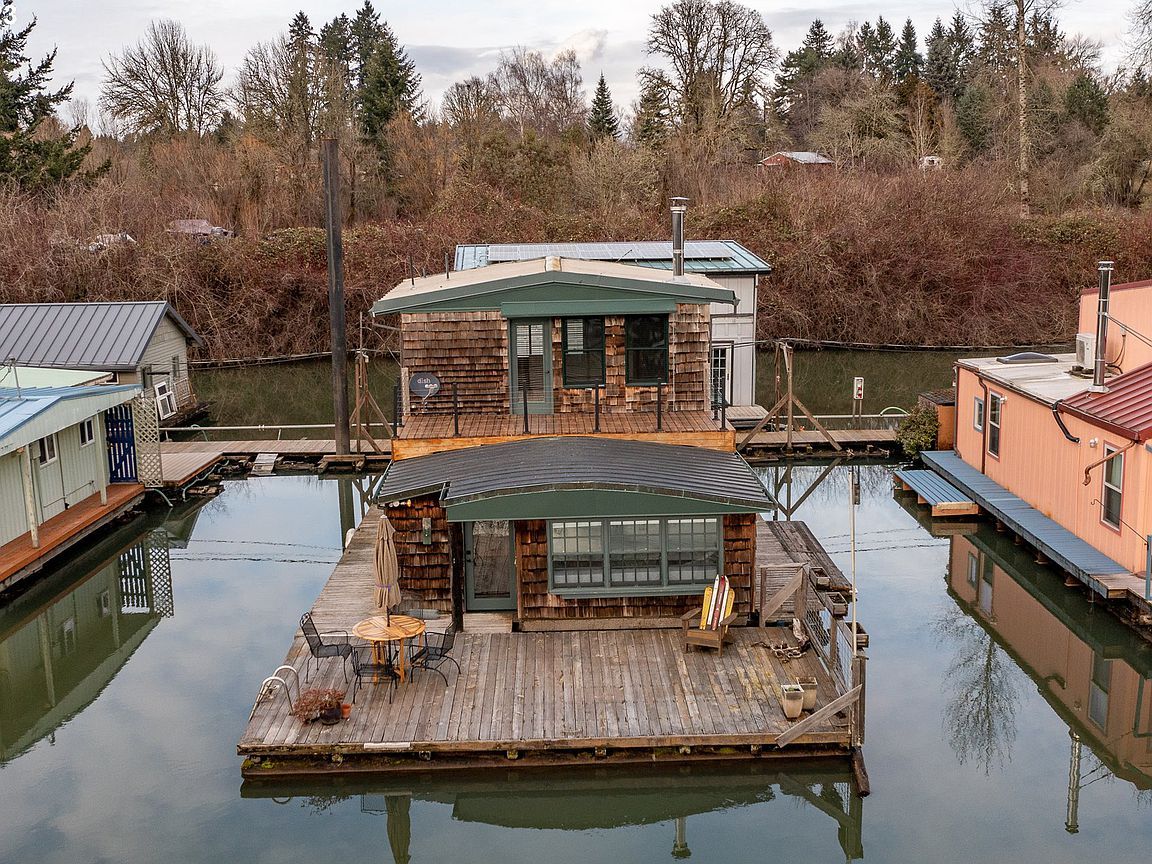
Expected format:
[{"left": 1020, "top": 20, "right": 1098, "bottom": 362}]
[{"left": 0, "top": 300, "right": 202, "bottom": 371}]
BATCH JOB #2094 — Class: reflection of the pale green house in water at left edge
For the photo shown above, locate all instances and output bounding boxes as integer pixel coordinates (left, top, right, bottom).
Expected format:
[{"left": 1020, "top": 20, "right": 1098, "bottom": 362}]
[{"left": 0, "top": 508, "right": 195, "bottom": 764}]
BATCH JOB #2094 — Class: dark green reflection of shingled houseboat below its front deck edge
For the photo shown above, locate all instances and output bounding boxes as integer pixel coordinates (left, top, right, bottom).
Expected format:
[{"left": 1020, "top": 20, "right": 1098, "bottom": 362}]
[{"left": 241, "top": 760, "right": 864, "bottom": 863}]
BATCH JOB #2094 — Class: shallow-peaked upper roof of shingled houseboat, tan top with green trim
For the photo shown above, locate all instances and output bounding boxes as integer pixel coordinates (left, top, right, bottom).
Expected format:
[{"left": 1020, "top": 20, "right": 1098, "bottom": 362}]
[{"left": 372, "top": 265, "right": 736, "bottom": 316}]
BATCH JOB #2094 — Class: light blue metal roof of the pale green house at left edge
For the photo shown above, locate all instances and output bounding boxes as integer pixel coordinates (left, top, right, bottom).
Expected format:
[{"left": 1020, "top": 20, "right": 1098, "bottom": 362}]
[{"left": 0, "top": 384, "right": 141, "bottom": 455}]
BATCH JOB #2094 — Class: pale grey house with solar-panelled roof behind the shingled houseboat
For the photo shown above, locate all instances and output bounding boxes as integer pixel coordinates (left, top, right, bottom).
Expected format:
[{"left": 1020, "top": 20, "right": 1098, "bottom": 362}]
[{"left": 455, "top": 205, "right": 772, "bottom": 425}]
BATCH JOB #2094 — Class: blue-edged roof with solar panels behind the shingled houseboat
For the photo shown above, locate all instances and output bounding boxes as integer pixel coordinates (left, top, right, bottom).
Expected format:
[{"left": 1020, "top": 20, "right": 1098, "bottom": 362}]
[{"left": 454, "top": 240, "right": 772, "bottom": 274}]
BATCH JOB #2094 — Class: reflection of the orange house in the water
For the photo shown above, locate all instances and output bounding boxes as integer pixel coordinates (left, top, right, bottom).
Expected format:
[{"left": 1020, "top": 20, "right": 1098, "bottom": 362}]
[{"left": 948, "top": 524, "right": 1152, "bottom": 831}]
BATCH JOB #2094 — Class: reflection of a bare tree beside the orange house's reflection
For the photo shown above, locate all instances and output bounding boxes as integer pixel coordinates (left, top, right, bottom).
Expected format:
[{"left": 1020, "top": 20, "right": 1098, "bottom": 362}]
[{"left": 934, "top": 606, "right": 1022, "bottom": 775}]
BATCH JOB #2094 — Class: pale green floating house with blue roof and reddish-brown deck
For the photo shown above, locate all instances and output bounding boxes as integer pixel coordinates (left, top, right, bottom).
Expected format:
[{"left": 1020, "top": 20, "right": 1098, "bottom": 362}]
[{"left": 0, "top": 385, "right": 144, "bottom": 590}]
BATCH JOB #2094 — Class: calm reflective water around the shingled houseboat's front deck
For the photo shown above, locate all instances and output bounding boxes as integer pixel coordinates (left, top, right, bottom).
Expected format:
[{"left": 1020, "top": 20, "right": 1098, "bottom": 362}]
[{"left": 0, "top": 465, "right": 1152, "bottom": 864}]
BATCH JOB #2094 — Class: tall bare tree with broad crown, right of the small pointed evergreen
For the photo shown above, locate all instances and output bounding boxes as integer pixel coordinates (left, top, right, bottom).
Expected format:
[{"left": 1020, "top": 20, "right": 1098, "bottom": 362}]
[{"left": 647, "top": 0, "right": 778, "bottom": 127}]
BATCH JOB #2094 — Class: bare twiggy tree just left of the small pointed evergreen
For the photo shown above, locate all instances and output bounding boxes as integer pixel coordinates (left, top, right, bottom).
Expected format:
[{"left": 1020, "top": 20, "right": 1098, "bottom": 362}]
[{"left": 488, "top": 47, "right": 588, "bottom": 137}]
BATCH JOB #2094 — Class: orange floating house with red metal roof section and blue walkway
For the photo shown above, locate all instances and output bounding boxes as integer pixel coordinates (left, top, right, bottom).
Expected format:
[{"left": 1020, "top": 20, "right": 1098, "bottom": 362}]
[{"left": 924, "top": 263, "right": 1152, "bottom": 615}]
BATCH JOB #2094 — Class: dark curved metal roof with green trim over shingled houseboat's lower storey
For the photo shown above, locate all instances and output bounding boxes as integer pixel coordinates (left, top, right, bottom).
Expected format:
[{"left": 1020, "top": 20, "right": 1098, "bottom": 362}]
[{"left": 378, "top": 435, "right": 775, "bottom": 521}]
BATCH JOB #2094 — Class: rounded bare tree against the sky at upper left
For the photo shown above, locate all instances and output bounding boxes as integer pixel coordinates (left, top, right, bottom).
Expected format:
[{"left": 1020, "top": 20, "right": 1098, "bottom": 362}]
[{"left": 100, "top": 21, "right": 223, "bottom": 135}]
